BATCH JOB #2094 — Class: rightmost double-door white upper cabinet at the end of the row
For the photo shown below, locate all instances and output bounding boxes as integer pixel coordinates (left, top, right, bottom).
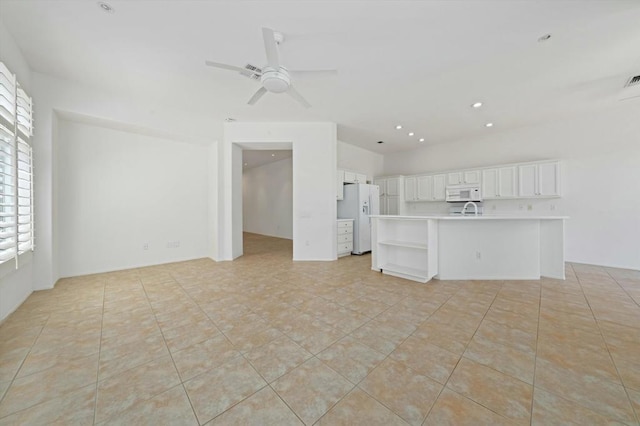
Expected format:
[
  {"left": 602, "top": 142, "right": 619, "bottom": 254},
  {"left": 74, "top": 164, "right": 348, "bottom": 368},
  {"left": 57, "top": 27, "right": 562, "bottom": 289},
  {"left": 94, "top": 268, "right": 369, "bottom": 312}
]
[{"left": 518, "top": 161, "right": 560, "bottom": 198}]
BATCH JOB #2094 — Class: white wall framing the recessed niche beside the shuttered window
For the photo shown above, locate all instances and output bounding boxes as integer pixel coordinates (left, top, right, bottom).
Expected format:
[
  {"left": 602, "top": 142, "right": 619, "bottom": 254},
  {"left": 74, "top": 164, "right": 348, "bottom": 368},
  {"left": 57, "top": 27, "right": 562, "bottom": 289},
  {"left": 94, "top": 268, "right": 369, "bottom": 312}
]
[{"left": 32, "top": 73, "right": 222, "bottom": 290}]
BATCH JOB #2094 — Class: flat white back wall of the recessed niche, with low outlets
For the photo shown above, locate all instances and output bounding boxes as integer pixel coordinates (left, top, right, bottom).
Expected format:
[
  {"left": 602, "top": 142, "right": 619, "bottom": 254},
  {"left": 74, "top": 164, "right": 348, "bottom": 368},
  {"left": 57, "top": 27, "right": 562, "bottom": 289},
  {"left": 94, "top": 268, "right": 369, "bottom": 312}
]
[{"left": 56, "top": 120, "right": 208, "bottom": 277}]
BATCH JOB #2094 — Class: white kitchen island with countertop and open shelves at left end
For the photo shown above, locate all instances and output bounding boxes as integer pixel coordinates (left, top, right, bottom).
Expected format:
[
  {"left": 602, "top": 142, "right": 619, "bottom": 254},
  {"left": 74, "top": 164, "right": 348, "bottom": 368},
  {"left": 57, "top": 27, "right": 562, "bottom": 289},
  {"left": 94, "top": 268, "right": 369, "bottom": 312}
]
[{"left": 371, "top": 215, "right": 568, "bottom": 282}]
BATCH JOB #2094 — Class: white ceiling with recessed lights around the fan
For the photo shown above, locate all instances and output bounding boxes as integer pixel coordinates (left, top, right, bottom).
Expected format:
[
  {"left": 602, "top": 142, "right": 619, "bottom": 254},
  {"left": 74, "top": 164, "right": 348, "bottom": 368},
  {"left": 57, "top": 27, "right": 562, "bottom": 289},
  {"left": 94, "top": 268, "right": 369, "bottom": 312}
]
[{"left": 0, "top": 0, "right": 640, "bottom": 153}]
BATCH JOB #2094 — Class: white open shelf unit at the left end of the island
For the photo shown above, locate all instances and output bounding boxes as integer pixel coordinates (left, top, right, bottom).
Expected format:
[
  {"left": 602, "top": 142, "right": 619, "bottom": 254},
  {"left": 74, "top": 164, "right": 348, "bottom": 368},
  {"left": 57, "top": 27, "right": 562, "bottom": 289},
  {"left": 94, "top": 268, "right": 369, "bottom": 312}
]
[{"left": 371, "top": 216, "right": 438, "bottom": 283}]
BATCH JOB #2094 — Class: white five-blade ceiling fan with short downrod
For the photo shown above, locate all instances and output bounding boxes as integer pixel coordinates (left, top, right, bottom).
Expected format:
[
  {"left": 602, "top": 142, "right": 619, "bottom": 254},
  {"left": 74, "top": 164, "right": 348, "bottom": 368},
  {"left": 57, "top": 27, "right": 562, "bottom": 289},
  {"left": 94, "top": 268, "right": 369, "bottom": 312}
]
[{"left": 205, "top": 28, "right": 337, "bottom": 108}]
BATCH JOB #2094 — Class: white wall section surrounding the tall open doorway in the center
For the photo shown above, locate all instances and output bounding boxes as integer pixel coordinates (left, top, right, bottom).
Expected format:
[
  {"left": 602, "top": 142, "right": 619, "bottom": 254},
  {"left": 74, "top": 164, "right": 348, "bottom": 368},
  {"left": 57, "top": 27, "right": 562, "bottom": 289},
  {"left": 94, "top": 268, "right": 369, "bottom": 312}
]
[{"left": 219, "top": 122, "right": 337, "bottom": 260}]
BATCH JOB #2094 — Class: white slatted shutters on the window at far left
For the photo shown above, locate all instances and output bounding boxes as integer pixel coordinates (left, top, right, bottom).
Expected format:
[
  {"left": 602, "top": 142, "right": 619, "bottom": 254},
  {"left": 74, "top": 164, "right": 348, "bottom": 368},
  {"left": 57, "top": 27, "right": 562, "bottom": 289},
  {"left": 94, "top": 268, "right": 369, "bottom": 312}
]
[{"left": 0, "top": 62, "right": 34, "bottom": 267}]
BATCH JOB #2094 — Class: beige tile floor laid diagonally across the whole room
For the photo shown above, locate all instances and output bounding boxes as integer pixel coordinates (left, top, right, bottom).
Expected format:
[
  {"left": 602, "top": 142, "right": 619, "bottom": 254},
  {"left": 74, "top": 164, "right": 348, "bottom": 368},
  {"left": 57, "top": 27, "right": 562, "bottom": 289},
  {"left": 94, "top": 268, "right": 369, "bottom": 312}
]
[{"left": 0, "top": 234, "right": 640, "bottom": 425}]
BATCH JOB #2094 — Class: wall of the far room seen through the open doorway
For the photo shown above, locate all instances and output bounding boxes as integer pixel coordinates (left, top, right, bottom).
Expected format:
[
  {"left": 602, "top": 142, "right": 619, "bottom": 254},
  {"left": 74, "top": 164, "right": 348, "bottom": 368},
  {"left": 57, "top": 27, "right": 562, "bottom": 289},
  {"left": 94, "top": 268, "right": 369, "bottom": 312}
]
[{"left": 242, "top": 158, "right": 293, "bottom": 240}]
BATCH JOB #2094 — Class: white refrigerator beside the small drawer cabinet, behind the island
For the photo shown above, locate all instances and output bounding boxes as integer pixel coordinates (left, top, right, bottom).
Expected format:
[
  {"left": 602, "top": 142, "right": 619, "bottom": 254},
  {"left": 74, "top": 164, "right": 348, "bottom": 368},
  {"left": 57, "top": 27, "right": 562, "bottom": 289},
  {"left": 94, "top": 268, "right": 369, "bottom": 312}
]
[{"left": 338, "top": 183, "right": 380, "bottom": 254}]
